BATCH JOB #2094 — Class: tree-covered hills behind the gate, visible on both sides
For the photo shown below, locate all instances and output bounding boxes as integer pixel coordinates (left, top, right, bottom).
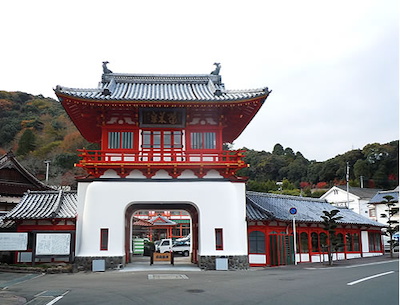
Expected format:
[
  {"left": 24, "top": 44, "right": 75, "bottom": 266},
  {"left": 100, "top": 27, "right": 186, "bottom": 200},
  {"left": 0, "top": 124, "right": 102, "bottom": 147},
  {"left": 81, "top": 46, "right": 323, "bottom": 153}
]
[{"left": 0, "top": 91, "right": 399, "bottom": 197}]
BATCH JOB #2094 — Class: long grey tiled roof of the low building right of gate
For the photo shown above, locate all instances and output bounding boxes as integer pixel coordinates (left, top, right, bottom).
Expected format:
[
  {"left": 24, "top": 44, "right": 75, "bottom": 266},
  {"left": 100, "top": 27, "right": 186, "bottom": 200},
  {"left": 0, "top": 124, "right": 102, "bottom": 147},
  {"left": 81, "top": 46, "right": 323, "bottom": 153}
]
[{"left": 246, "top": 191, "right": 385, "bottom": 227}]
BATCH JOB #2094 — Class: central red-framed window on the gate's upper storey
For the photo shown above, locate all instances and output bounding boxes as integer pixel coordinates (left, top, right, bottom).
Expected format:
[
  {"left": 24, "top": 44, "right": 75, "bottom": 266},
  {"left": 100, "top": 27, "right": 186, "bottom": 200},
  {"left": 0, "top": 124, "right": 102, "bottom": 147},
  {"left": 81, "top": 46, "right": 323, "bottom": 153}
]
[{"left": 142, "top": 130, "right": 183, "bottom": 149}]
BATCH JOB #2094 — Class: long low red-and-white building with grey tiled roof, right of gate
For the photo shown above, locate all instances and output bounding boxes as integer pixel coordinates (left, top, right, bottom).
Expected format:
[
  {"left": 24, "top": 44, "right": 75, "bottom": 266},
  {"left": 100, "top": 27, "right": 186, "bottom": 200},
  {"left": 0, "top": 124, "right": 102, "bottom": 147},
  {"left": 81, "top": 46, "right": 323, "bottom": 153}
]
[{"left": 246, "top": 192, "right": 385, "bottom": 266}]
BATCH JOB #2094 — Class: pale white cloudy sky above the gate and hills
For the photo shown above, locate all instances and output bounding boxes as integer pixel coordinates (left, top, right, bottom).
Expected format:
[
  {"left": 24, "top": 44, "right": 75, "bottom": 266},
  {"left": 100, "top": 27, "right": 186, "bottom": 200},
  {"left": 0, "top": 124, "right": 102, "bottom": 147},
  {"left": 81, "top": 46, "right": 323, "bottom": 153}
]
[{"left": 0, "top": 0, "right": 399, "bottom": 161}]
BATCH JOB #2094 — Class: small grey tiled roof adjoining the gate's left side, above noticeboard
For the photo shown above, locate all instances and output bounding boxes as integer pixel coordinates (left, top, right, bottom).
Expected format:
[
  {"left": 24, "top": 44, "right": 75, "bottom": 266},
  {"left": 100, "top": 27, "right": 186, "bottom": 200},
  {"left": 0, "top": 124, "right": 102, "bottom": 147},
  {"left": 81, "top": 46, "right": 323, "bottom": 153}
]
[{"left": 5, "top": 191, "right": 77, "bottom": 220}]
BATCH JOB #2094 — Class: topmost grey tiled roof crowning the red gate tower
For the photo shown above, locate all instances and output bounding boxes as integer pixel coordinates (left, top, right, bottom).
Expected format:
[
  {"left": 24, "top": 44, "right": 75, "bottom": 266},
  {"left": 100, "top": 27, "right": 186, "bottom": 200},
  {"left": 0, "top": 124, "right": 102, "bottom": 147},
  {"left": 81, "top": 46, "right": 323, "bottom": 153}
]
[{"left": 55, "top": 73, "right": 269, "bottom": 102}]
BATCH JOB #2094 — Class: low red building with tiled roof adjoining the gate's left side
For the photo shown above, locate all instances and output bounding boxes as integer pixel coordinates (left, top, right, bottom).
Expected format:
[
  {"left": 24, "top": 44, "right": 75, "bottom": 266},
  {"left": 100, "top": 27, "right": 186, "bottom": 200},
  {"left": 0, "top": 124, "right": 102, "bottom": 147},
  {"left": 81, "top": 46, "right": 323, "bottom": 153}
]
[{"left": 0, "top": 190, "right": 77, "bottom": 263}]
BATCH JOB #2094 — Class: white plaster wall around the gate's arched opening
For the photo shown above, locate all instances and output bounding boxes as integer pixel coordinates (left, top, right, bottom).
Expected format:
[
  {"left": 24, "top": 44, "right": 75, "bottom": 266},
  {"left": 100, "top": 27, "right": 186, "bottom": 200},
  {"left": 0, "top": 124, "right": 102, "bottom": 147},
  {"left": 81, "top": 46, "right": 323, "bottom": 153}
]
[{"left": 76, "top": 179, "right": 247, "bottom": 256}]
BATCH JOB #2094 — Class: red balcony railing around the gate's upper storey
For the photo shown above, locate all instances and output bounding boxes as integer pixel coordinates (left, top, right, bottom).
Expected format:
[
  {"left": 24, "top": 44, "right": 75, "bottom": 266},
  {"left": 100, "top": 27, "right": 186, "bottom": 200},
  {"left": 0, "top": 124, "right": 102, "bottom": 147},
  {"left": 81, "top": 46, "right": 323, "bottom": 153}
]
[{"left": 77, "top": 150, "right": 247, "bottom": 177}]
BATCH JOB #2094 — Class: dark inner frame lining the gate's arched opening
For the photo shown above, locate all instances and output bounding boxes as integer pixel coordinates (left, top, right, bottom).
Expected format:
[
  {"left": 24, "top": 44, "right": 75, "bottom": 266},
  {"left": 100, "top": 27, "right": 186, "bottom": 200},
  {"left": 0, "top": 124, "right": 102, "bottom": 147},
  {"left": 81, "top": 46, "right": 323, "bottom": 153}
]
[{"left": 125, "top": 202, "right": 199, "bottom": 264}]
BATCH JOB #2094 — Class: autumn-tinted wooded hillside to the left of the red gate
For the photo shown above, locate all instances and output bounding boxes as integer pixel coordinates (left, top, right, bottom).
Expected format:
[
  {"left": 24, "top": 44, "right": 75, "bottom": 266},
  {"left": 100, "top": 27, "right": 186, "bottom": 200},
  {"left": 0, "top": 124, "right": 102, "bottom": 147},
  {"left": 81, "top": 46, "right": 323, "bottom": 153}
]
[{"left": 0, "top": 91, "right": 95, "bottom": 186}]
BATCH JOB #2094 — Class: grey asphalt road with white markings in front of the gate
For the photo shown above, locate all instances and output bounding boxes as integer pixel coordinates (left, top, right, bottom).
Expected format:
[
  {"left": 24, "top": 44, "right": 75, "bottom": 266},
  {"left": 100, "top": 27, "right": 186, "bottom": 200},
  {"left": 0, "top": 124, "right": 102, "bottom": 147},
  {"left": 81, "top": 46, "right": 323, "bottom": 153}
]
[{"left": 0, "top": 258, "right": 399, "bottom": 305}]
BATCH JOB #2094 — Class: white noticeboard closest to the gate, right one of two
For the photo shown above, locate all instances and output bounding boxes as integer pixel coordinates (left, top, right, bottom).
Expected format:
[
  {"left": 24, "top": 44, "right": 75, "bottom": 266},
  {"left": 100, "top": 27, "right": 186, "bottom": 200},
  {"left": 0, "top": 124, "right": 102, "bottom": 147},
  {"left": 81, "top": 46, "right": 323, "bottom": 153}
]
[{"left": 35, "top": 233, "right": 71, "bottom": 255}]
